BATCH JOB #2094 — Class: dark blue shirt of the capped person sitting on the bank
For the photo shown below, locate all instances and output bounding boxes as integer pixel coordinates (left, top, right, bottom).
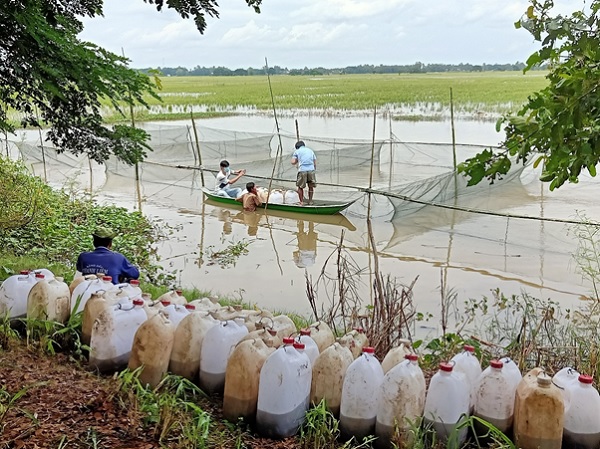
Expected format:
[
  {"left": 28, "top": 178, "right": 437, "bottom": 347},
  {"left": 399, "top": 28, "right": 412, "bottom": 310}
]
[{"left": 77, "top": 246, "right": 140, "bottom": 284}]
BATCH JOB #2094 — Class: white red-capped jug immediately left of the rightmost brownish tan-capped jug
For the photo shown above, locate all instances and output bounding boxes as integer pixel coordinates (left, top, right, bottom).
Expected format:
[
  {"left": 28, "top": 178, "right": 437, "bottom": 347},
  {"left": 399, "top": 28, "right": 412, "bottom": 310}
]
[{"left": 473, "top": 360, "right": 520, "bottom": 437}]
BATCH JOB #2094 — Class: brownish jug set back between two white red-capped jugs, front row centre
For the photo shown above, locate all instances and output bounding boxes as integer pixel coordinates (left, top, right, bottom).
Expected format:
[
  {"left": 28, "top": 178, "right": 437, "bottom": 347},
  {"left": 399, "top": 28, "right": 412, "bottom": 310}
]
[{"left": 310, "top": 343, "right": 354, "bottom": 417}]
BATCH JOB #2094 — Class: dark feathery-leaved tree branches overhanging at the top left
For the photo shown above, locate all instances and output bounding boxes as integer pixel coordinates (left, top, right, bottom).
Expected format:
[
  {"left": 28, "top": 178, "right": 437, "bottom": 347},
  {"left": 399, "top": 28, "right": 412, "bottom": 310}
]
[{"left": 0, "top": 0, "right": 262, "bottom": 163}]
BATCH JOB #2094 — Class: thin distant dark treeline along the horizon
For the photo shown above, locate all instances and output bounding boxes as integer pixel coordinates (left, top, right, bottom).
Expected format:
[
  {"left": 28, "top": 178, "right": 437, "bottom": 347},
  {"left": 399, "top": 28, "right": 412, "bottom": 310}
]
[{"left": 140, "top": 62, "right": 525, "bottom": 76}]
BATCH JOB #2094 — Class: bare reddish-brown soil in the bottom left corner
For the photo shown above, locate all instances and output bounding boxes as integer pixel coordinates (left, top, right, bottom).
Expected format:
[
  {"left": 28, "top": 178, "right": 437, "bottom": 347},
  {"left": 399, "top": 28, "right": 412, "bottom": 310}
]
[{"left": 0, "top": 341, "right": 300, "bottom": 449}]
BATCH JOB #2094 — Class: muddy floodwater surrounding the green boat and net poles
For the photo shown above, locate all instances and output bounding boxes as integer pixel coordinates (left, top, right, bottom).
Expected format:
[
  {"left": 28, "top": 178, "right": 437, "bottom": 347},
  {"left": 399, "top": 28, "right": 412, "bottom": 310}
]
[{"left": 11, "top": 116, "right": 600, "bottom": 335}]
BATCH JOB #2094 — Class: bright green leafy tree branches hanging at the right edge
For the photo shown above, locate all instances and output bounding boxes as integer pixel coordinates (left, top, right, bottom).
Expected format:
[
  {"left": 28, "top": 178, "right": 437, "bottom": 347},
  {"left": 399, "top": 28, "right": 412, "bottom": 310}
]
[{"left": 459, "top": 0, "right": 600, "bottom": 190}]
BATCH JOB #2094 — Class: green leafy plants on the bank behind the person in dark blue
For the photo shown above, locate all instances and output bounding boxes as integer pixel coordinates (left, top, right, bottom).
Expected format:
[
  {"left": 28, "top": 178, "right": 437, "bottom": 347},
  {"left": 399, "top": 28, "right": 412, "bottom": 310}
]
[{"left": 0, "top": 157, "right": 170, "bottom": 284}]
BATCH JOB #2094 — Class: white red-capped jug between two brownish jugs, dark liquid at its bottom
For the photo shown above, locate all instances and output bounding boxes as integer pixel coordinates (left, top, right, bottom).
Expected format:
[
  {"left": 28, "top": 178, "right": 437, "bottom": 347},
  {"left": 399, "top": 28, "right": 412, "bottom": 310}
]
[{"left": 340, "top": 346, "right": 383, "bottom": 441}]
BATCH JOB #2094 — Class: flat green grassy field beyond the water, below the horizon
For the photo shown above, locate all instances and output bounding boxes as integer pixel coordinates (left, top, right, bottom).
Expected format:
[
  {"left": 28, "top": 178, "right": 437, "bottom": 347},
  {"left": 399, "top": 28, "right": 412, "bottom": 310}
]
[{"left": 101, "top": 72, "right": 547, "bottom": 119}]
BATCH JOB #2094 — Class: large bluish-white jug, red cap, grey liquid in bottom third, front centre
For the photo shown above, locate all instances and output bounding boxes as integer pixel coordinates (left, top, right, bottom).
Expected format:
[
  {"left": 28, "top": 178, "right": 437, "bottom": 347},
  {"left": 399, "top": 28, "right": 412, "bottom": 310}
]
[{"left": 256, "top": 338, "right": 311, "bottom": 438}]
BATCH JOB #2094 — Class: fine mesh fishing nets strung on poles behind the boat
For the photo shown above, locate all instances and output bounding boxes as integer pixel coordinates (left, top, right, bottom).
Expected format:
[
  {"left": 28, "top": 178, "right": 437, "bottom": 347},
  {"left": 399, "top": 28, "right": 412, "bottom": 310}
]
[{"left": 7, "top": 124, "right": 523, "bottom": 220}]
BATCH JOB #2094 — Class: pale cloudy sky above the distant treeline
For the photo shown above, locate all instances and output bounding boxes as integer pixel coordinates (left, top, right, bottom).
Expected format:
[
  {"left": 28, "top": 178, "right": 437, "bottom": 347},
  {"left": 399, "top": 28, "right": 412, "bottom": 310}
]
[{"left": 80, "top": 0, "right": 583, "bottom": 70}]
